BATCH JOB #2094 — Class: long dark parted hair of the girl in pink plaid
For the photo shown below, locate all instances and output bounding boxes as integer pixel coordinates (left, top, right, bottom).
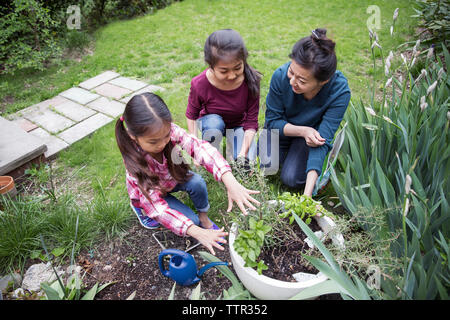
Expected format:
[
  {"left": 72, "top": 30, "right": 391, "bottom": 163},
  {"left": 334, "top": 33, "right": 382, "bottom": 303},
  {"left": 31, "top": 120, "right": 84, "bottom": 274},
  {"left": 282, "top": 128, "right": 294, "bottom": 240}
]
[{"left": 115, "top": 92, "right": 190, "bottom": 198}]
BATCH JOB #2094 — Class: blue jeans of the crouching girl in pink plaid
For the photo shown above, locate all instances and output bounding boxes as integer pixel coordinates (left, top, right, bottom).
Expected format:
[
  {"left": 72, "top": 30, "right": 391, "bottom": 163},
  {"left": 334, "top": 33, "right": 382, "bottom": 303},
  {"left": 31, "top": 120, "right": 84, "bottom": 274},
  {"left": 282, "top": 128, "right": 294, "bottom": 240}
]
[{"left": 163, "top": 171, "right": 210, "bottom": 226}]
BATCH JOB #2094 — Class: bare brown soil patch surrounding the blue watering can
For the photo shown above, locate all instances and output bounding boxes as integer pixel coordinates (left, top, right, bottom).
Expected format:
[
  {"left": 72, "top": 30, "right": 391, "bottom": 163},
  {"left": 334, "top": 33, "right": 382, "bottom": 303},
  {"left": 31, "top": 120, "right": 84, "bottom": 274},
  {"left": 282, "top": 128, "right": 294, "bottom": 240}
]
[{"left": 78, "top": 222, "right": 234, "bottom": 300}]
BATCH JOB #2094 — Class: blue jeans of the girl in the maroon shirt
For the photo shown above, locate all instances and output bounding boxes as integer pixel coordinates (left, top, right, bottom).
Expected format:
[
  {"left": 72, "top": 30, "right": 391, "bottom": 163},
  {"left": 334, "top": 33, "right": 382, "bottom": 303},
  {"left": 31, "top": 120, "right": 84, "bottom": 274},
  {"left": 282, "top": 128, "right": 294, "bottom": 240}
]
[{"left": 197, "top": 113, "right": 256, "bottom": 160}]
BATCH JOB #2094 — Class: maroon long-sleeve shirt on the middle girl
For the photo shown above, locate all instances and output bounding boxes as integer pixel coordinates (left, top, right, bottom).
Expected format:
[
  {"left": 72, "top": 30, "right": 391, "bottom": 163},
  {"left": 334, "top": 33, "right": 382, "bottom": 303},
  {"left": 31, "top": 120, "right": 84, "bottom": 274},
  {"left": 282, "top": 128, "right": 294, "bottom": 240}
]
[{"left": 186, "top": 69, "right": 259, "bottom": 131}]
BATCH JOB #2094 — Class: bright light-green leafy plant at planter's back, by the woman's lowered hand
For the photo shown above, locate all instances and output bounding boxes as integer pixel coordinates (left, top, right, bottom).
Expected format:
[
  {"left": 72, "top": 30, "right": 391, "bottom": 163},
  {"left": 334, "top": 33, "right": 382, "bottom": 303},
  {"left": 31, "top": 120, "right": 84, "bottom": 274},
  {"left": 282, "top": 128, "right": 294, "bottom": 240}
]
[{"left": 278, "top": 192, "right": 332, "bottom": 224}]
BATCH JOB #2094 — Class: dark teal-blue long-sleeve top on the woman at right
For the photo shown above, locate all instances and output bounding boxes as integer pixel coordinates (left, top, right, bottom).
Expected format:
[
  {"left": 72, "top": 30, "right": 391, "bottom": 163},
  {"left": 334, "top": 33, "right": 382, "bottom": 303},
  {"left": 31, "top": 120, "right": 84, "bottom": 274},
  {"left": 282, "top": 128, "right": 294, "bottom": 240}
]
[{"left": 265, "top": 62, "right": 351, "bottom": 175}]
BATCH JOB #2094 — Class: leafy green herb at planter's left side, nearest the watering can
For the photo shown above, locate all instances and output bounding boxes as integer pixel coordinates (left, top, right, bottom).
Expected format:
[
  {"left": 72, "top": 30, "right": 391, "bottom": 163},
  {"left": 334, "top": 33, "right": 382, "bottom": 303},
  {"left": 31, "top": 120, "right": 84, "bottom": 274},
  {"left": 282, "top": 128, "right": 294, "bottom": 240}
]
[{"left": 234, "top": 217, "right": 272, "bottom": 274}]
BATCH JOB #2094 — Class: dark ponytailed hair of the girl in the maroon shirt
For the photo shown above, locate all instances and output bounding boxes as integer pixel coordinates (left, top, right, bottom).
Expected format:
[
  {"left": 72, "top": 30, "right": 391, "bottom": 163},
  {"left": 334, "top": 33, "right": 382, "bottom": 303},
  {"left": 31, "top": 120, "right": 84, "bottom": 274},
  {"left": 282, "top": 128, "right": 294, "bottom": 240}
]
[{"left": 204, "top": 29, "right": 261, "bottom": 97}]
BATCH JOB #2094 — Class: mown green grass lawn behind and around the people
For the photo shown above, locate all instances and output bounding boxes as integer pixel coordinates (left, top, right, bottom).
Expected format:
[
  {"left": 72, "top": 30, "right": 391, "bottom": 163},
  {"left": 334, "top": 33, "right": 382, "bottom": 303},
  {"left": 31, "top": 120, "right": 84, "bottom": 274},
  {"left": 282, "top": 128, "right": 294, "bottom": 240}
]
[{"left": 0, "top": 0, "right": 415, "bottom": 270}]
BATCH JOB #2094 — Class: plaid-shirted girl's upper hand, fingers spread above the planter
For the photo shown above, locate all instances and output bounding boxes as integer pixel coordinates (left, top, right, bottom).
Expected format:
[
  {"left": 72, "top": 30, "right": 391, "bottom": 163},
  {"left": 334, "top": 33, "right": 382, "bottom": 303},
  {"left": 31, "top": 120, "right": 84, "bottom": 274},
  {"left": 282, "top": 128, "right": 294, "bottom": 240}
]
[{"left": 222, "top": 171, "right": 259, "bottom": 215}]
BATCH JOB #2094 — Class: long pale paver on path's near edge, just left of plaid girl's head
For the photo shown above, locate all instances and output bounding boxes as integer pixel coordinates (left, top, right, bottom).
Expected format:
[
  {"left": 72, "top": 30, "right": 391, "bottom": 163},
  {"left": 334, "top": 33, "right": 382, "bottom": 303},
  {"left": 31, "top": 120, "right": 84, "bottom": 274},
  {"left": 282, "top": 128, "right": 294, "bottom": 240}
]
[{"left": 57, "top": 113, "right": 114, "bottom": 144}]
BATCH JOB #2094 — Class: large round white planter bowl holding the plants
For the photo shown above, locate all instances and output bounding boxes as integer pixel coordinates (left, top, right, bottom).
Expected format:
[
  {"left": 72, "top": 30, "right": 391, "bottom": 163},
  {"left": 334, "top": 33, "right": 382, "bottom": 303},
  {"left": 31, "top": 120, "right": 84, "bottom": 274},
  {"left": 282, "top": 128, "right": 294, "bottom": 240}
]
[{"left": 229, "top": 212, "right": 344, "bottom": 300}]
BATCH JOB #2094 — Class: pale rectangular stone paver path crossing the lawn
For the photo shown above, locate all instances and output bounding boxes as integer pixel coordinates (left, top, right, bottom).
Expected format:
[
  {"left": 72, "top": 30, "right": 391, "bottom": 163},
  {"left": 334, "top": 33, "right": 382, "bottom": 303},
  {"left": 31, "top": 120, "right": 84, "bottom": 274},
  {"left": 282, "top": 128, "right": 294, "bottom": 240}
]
[{"left": 7, "top": 71, "right": 164, "bottom": 158}]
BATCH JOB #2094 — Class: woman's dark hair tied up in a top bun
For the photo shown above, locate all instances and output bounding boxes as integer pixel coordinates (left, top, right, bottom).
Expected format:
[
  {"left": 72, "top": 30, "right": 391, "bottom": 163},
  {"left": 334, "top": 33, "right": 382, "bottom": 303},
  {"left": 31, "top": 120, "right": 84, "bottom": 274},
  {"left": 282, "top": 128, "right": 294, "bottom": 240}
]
[{"left": 289, "top": 29, "right": 337, "bottom": 81}]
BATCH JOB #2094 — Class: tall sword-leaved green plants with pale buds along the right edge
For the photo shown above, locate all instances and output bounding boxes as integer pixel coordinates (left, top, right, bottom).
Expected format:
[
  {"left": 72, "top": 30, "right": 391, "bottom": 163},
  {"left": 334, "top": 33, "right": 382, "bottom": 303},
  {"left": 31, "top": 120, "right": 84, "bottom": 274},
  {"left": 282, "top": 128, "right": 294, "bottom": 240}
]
[{"left": 332, "top": 8, "right": 450, "bottom": 299}]
